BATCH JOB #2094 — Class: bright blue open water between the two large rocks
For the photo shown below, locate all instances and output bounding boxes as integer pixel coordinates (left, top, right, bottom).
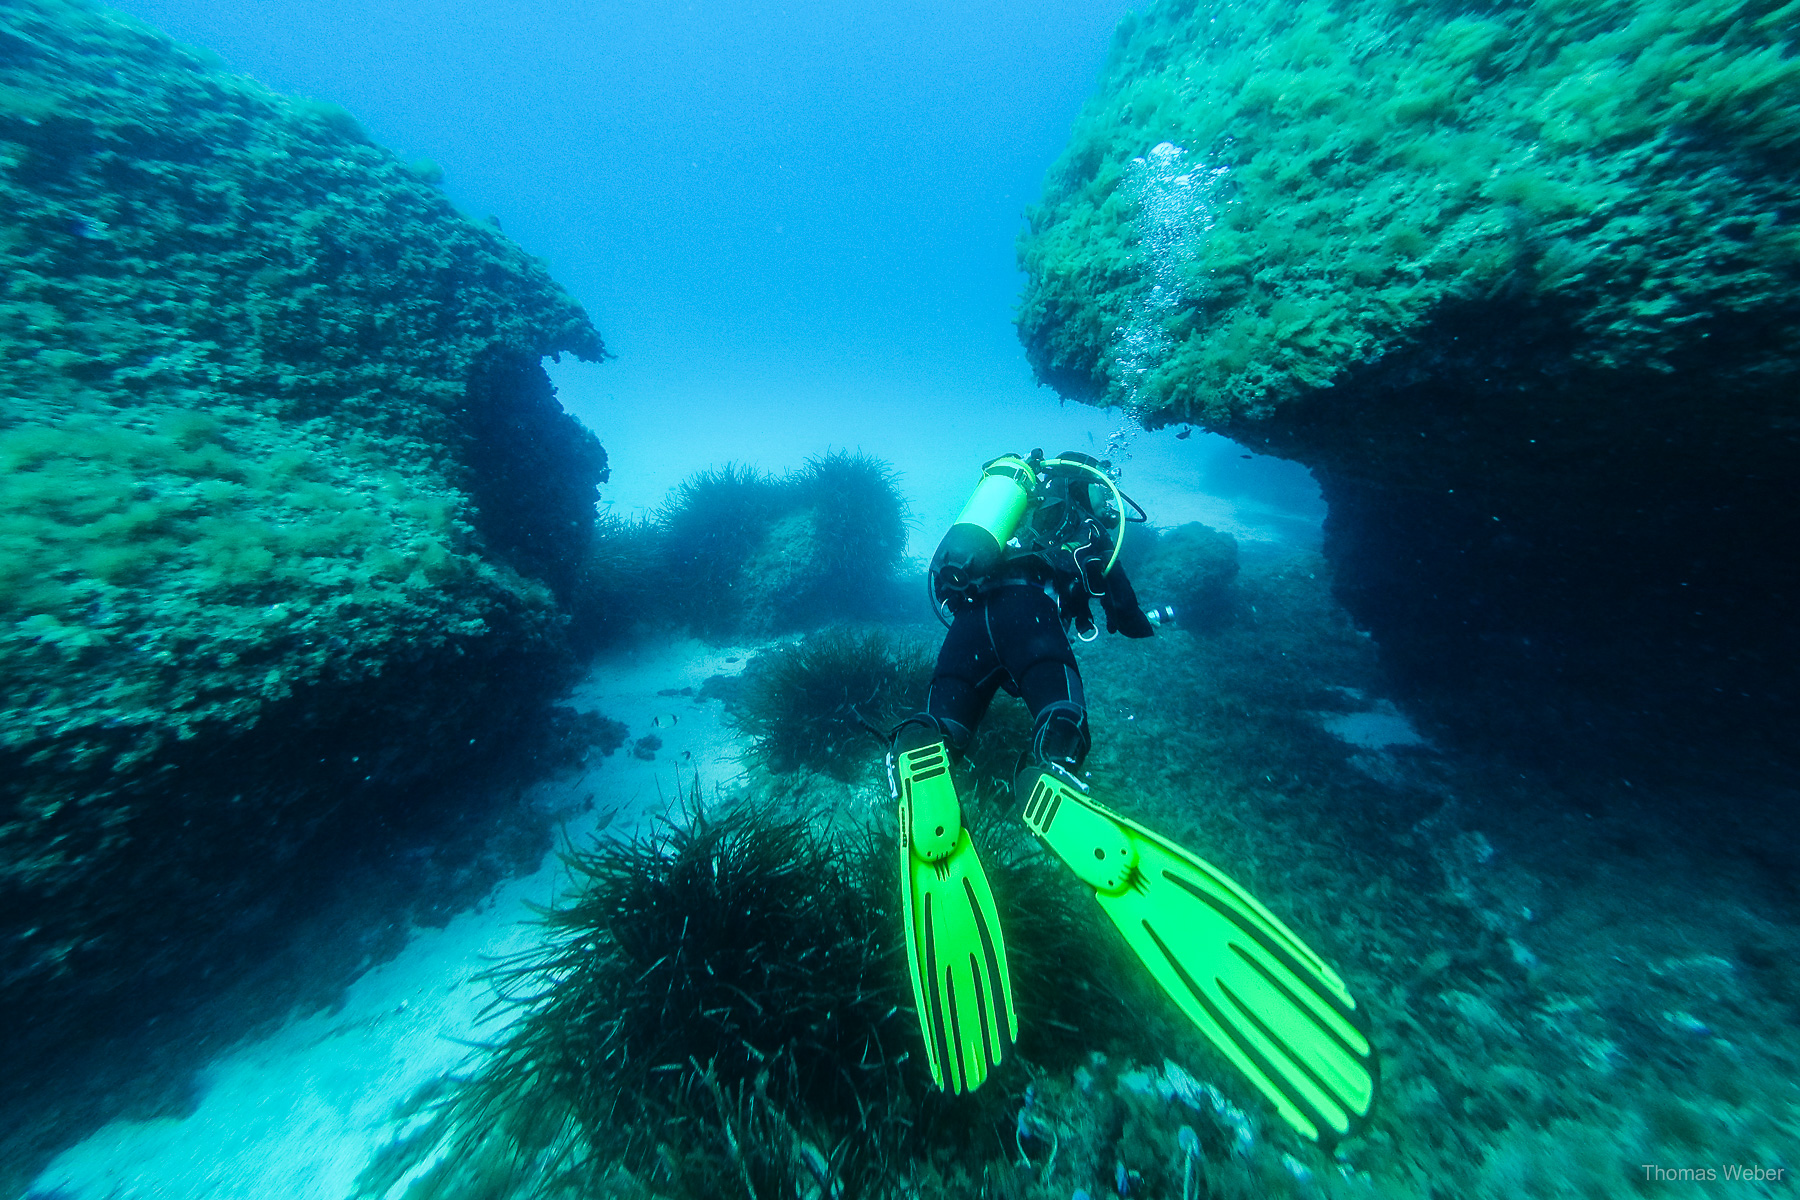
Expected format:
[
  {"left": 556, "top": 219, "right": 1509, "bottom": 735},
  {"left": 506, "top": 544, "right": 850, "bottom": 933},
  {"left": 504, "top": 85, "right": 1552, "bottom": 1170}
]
[{"left": 108, "top": 0, "right": 1323, "bottom": 554}]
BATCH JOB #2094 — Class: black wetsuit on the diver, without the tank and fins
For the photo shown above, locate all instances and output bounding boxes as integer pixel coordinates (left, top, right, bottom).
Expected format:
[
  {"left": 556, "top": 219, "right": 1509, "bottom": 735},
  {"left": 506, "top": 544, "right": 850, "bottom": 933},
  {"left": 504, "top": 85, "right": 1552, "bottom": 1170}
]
[{"left": 895, "top": 455, "right": 1154, "bottom": 784}]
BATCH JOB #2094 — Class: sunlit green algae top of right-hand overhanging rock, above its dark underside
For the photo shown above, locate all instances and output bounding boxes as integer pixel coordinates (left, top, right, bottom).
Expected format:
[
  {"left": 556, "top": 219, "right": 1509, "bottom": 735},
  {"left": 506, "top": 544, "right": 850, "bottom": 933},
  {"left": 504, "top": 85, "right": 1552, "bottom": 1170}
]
[{"left": 1019, "top": 0, "right": 1800, "bottom": 425}]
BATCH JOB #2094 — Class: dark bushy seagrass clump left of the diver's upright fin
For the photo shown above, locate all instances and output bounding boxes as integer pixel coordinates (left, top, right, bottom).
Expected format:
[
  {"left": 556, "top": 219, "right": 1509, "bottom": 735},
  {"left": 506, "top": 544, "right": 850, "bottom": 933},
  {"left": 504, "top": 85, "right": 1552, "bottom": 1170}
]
[{"left": 378, "top": 786, "right": 913, "bottom": 1196}]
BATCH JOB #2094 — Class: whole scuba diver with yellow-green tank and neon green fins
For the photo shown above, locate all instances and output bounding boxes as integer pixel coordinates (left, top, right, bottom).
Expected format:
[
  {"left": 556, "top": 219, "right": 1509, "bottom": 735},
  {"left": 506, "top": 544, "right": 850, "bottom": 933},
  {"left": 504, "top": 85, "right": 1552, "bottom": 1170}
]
[{"left": 887, "top": 450, "right": 1377, "bottom": 1148}]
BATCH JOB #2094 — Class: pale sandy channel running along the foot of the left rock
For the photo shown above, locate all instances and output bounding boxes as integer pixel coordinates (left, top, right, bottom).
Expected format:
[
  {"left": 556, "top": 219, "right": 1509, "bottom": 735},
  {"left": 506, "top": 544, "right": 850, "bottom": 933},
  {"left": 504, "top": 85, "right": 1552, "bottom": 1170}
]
[{"left": 25, "top": 640, "right": 749, "bottom": 1200}]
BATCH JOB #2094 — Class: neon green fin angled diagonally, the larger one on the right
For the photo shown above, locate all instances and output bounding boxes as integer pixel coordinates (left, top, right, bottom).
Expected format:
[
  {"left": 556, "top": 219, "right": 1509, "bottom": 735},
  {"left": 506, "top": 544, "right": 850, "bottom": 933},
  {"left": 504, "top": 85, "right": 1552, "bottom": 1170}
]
[{"left": 1024, "top": 772, "right": 1379, "bottom": 1148}]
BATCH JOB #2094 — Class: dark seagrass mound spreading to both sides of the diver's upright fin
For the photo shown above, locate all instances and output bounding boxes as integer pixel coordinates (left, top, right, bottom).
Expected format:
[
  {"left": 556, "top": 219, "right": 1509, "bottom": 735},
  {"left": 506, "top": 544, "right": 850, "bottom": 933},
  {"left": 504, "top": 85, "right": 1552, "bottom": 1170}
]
[{"left": 355, "top": 781, "right": 1147, "bottom": 1200}]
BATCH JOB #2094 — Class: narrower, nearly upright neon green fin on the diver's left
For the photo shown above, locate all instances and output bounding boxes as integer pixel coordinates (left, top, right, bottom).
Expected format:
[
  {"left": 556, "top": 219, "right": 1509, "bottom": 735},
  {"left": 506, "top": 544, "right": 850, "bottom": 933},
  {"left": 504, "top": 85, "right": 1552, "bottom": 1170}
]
[{"left": 887, "top": 741, "right": 1019, "bottom": 1092}]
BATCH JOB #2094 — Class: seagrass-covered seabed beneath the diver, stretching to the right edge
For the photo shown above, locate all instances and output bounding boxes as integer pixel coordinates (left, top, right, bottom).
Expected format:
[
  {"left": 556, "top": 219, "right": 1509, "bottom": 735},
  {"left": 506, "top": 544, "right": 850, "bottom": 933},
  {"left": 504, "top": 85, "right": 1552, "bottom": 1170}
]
[{"left": 347, "top": 554, "right": 1800, "bottom": 1200}]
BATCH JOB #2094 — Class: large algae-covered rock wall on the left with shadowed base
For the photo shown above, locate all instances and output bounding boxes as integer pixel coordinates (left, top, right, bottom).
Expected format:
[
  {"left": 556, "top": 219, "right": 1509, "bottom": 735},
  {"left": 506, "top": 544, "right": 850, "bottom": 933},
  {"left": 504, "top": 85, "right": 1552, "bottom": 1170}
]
[{"left": 0, "top": 0, "right": 605, "bottom": 1007}]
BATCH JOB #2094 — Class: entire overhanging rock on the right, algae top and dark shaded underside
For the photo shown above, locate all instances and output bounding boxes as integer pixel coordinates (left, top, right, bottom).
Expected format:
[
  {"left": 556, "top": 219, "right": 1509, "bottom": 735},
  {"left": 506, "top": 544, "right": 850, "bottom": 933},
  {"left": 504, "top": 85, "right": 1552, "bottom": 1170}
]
[{"left": 1019, "top": 0, "right": 1800, "bottom": 755}]
